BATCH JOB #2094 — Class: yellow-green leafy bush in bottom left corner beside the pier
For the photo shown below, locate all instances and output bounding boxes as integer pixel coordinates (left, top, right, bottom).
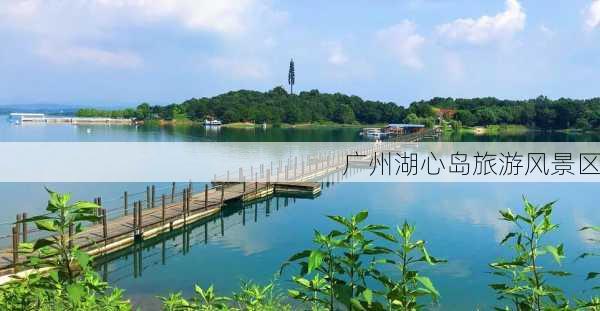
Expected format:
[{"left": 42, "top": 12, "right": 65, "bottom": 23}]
[{"left": 0, "top": 190, "right": 131, "bottom": 311}]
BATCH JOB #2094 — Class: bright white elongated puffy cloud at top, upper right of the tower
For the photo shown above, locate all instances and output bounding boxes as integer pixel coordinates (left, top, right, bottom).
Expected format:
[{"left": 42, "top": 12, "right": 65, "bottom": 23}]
[{"left": 437, "top": 0, "right": 526, "bottom": 44}]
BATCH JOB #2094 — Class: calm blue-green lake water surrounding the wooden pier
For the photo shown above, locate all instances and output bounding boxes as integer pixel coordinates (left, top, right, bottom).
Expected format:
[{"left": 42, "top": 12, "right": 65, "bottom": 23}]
[{"left": 0, "top": 116, "right": 600, "bottom": 310}]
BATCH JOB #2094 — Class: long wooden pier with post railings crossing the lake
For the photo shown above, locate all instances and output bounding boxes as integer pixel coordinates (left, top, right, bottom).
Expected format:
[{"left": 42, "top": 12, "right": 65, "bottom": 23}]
[{"left": 0, "top": 128, "right": 433, "bottom": 284}]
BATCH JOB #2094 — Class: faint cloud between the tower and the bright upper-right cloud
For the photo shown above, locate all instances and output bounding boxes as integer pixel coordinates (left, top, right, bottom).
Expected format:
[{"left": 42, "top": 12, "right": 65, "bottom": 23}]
[{"left": 376, "top": 20, "right": 425, "bottom": 69}]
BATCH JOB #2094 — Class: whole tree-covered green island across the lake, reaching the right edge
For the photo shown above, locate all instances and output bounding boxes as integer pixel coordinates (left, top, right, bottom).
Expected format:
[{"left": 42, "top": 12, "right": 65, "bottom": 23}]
[{"left": 76, "top": 87, "right": 600, "bottom": 133}]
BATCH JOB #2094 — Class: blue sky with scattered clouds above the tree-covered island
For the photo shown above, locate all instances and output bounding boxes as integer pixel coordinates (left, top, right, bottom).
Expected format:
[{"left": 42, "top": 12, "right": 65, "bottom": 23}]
[{"left": 0, "top": 0, "right": 600, "bottom": 105}]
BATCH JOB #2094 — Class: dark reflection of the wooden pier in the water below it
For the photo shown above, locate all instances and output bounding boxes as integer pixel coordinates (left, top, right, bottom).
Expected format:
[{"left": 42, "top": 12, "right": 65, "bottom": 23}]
[{"left": 95, "top": 195, "right": 314, "bottom": 290}]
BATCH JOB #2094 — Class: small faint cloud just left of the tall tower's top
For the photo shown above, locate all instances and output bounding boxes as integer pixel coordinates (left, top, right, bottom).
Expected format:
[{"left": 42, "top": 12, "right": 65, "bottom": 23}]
[{"left": 209, "top": 57, "right": 269, "bottom": 79}]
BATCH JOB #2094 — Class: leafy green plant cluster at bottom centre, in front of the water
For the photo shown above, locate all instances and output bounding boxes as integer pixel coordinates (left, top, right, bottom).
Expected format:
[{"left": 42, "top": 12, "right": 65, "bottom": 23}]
[{"left": 282, "top": 211, "right": 441, "bottom": 310}]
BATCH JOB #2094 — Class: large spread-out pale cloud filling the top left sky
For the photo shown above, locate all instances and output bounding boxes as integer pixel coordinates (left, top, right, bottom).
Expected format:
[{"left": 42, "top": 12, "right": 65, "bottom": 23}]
[{"left": 0, "top": 0, "right": 285, "bottom": 68}]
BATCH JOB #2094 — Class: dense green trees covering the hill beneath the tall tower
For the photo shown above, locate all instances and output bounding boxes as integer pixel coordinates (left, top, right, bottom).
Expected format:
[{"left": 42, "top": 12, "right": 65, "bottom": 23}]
[{"left": 78, "top": 86, "right": 405, "bottom": 124}]
